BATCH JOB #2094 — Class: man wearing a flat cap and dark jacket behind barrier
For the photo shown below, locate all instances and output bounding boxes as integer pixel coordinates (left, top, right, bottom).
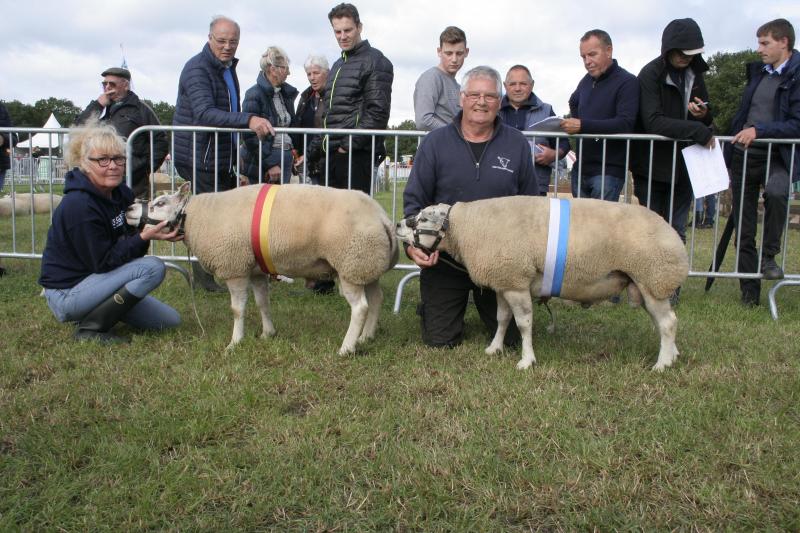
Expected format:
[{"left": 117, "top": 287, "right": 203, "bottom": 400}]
[{"left": 75, "top": 67, "right": 169, "bottom": 198}]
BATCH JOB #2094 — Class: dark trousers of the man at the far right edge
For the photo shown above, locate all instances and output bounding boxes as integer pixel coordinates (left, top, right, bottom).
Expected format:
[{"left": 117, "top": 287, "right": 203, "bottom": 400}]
[{"left": 731, "top": 147, "right": 791, "bottom": 295}]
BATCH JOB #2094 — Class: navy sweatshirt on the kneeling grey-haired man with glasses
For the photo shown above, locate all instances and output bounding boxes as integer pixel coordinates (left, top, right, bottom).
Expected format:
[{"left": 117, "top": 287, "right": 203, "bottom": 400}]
[{"left": 403, "top": 112, "right": 539, "bottom": 217}]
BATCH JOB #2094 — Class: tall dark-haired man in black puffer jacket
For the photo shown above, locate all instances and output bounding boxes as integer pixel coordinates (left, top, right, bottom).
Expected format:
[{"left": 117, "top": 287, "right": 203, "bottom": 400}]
[{"left": 322, "top": 4, "right": 394, "bottom": 194}]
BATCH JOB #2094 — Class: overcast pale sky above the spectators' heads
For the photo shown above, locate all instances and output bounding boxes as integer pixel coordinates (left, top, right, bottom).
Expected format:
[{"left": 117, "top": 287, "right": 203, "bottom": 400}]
[{"left": 0, "top": 0, "right": 800, "bottom": 125}]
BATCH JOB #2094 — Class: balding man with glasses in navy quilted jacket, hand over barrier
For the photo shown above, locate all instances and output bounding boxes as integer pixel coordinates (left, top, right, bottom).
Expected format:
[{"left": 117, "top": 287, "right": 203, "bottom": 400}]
[{"left": 172, "top": 16, "right": 275, "bottom": 292}]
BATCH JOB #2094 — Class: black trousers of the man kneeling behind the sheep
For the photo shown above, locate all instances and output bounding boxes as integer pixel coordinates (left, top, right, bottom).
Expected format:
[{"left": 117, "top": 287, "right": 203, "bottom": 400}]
[{"left": 417, "top": 256, "right": 521, "bottom": 347}]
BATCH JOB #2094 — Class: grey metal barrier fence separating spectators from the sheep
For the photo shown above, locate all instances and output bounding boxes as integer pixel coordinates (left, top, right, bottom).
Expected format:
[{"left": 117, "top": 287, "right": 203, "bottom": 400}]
[{"left": 0, "top": 126, "right": 800, "bottom": 319}]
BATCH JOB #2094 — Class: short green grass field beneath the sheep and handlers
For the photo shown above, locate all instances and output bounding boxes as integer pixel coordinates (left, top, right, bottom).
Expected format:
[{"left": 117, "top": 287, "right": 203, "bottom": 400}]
[{"left": 0, "top": 191, "right": 800, "bottom": 531}]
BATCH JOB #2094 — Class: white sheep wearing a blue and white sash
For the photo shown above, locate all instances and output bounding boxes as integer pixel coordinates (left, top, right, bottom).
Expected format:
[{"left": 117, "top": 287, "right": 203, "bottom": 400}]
[{"left": 397, "top": 196, "right": 689, "bottom": 370}]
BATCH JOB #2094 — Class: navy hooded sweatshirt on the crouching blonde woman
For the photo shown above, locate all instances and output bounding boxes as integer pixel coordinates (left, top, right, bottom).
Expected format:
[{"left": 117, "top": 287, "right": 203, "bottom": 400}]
[{"left": 39, "top": 168, "right": 149, "bottom": 289}]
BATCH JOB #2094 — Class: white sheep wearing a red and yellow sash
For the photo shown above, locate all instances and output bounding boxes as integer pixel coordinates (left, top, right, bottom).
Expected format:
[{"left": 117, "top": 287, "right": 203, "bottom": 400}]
[{"left": 126, "top": 183, "right": 398, "bottom": 354}]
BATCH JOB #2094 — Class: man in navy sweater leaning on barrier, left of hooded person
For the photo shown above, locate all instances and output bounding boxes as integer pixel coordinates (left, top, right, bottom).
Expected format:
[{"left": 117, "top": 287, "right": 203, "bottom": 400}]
[{"left": 561, "top": 30, "right": 639, "bottom": 202}]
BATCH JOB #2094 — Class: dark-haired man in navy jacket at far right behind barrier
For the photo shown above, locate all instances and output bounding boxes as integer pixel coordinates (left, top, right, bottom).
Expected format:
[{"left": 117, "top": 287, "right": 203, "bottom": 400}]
[{"left": 728, "top": 19, "right": 800, "bottom": 306}]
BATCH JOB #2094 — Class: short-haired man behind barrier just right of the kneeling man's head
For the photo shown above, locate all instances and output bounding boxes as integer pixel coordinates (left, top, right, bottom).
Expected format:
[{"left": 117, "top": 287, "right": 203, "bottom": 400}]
[{"left": 497, "top": 65, "right": 569, "bottom": 196}]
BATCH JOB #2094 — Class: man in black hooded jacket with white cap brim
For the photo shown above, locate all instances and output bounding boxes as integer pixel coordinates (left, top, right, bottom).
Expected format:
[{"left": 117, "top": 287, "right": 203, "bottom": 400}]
[{"left": 631, "top": 18, "right": 714, "bottom": 249}]
